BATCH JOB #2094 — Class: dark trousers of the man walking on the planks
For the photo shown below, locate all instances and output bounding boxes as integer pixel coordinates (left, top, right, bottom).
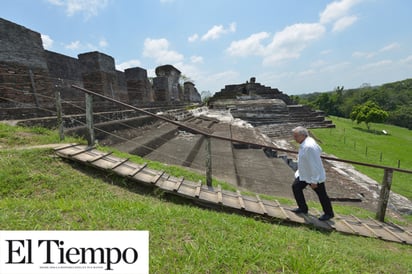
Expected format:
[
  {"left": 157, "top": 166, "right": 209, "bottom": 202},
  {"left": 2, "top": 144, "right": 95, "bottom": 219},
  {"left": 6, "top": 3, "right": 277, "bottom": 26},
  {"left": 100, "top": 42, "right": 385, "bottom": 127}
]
[{"left": 292, "top": 177, "right": 334, "bottom": 216}]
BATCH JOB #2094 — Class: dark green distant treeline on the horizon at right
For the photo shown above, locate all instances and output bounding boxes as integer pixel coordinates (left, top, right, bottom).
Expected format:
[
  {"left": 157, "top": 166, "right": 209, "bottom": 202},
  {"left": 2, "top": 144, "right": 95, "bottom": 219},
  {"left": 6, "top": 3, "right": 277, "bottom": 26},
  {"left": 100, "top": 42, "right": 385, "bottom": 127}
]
[{"left": 291, "top": 79, "right": 412, "bottom": 129}]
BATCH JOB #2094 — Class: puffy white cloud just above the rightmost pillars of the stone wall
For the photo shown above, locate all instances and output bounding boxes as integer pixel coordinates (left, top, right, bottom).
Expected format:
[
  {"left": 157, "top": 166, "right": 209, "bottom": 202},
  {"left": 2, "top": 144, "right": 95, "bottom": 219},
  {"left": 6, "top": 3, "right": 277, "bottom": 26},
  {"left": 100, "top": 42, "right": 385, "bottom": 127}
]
[{"left": 143, "top": 38, "right": 184, "bottom": 64}]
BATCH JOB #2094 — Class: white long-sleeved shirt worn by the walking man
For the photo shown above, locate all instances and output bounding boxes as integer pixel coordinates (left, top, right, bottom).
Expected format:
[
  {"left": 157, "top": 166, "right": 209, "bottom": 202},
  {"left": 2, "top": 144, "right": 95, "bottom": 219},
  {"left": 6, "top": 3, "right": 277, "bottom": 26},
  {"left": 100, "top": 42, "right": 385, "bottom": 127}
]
[{"left": 295, "top": 136, "right": 326, "bottom": 184}]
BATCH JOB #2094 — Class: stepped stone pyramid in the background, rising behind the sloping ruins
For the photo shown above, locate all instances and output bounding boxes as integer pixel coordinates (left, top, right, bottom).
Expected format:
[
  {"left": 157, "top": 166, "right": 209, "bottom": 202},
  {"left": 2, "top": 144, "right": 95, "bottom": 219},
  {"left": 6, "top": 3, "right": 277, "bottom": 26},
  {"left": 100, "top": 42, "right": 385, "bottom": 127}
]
[{"left": 209, "top": 77, "right": 334, "bottom": 137}]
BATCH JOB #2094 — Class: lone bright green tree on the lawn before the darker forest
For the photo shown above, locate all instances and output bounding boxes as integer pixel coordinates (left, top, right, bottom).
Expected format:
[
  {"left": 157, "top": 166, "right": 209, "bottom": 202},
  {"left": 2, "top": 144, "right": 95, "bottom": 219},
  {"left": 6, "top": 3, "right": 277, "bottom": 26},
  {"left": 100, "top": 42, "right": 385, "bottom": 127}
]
[{"left": 349, "top": 101, "right": 388, "bottom": 130}]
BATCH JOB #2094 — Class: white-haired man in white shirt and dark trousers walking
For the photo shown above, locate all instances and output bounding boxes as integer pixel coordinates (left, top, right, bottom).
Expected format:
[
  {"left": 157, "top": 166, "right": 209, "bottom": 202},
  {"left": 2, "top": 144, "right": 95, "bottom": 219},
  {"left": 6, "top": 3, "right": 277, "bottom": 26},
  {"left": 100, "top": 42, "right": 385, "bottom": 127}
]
[{"left": 292, "top": 126, "right": 334, "bottom": 221}]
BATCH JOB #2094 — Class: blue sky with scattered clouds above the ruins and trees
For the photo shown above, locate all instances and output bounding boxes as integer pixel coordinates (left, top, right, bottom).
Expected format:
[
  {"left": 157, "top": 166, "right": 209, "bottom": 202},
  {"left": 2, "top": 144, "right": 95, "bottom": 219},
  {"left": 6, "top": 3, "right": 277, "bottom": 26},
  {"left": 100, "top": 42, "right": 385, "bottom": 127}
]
[{"left": 0, "top": 0, "right": 412, "bottom": 95}]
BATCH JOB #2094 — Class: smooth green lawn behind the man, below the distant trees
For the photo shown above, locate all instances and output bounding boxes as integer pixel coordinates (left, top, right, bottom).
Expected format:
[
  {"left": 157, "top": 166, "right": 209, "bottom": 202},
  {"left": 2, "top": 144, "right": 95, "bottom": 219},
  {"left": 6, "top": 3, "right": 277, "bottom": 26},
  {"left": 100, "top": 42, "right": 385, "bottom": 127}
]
[{"left": 311, "top": 117, "right": 412, "bottom": 200}]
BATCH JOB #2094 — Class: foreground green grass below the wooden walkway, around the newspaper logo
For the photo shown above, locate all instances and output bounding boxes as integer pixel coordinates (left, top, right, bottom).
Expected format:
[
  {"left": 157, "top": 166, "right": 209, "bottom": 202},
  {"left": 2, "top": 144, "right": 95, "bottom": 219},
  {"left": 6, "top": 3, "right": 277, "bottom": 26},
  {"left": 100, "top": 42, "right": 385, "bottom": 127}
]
[{"left": 0, "top": 123, "right": 412, "bottom": 273}]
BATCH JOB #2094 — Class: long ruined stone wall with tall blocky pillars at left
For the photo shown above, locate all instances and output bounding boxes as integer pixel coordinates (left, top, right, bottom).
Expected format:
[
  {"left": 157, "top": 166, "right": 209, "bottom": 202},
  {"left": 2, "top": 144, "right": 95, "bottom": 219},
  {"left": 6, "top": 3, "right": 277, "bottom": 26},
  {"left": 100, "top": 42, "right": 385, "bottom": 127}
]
[{"left": 0, "top": 18, "right": 200, "bottom": 120}]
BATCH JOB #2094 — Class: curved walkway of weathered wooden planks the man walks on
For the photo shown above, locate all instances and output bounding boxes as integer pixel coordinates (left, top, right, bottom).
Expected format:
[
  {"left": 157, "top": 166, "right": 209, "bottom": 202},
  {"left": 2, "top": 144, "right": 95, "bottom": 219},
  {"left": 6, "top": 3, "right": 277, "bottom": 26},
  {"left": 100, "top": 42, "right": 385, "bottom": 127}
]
[{"left": 54, "top": 144, "right": 412, "bottom": 245}]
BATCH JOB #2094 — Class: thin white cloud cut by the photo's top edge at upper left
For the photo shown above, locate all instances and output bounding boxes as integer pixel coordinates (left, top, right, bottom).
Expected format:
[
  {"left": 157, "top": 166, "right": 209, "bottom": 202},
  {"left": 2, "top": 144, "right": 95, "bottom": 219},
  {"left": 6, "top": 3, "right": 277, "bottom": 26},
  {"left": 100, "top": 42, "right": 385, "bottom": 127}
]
[{"left": 47, "top": 0, "right": 109, "bottom": 19}]
